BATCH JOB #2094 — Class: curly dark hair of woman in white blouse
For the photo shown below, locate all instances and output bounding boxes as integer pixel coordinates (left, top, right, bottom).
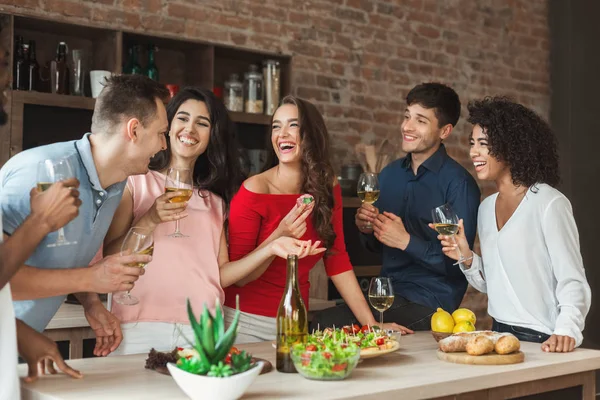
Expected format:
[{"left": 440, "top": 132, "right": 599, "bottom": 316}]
[{"left": 467, "top": 97, "right": 560, "bottom": 187}]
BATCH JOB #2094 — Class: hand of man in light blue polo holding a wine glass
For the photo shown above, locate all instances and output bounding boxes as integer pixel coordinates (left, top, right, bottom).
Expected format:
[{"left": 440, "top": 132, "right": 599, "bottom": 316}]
[{"left": 88, "top": 254, "right": 152, "bottom": 293}]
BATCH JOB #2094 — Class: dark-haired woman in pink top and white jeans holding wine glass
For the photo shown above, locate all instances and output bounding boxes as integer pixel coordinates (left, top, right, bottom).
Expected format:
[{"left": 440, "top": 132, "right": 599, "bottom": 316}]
[{"left": 105, "top": 88, "right": 325, "bottom": 354}]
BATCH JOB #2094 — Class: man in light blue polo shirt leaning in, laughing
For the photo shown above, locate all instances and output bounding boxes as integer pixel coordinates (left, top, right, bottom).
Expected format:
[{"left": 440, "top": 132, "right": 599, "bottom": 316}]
[{"left": 0, "top": 75, "right": 169, "bottom": 355}]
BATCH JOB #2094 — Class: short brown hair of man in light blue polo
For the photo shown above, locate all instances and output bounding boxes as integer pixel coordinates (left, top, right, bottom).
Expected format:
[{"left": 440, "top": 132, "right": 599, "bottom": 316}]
[{"left": 92, "top": 75, "right": 169, "bottom": 132}]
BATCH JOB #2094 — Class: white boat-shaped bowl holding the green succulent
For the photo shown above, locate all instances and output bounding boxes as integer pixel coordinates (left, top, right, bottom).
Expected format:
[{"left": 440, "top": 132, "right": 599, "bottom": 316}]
[{"left": 167, "top": 361, "right": 264, "bottom": 400}]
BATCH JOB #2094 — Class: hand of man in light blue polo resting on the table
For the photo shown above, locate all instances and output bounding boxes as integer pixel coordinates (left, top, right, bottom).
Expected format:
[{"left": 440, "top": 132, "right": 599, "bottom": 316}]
[{"left": 85, "top": 302, "right": 123, "bottom": 357}]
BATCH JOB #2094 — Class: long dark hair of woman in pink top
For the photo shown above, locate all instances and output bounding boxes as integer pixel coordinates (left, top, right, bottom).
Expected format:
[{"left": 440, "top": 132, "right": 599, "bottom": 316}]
[{"left": 150, "top": 87, "right": 246, "bottom": 210}]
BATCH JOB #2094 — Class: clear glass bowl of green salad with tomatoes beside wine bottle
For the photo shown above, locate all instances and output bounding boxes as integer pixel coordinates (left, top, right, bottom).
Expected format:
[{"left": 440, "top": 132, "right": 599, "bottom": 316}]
[{"left": 291, "top": 339, "right": 360, "bottom": 381}]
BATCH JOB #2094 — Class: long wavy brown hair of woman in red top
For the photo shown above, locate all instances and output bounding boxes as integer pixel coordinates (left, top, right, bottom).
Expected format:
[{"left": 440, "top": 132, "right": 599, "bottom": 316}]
[{"left": 265, "top": 96, "right": 336, "bottom": 252}]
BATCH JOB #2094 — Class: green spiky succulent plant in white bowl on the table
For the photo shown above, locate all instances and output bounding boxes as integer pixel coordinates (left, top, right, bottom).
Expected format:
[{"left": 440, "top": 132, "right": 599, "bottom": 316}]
[{"left": 167, "top": 299, "right": 263, "bottom": 400}]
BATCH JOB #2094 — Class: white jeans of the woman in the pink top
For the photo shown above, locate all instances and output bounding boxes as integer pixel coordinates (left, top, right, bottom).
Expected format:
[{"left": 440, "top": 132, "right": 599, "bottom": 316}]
[{"left": 110, "top": 322, "right": 194, "bottom": 356}]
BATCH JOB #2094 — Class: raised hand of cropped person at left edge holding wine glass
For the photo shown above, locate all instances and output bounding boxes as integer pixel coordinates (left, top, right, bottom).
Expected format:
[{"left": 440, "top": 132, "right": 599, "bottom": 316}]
[{"left": 29, "top": 178, "right": 81, "bottom": 233}]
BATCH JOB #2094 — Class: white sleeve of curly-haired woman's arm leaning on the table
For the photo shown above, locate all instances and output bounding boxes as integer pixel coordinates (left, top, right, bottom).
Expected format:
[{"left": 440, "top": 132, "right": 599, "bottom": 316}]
[{"left": 542, "top": 197, "right": 592, "bottom": 346}]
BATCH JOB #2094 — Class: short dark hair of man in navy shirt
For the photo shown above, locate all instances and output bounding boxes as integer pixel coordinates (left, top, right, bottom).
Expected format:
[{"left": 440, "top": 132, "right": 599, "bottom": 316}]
[{"left": 406, "top": 82, "right": 460, "bottom": 128}]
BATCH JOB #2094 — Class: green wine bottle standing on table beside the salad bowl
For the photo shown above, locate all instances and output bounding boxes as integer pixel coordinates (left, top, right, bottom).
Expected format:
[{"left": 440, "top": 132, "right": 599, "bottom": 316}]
[{"left": 276, "top": 254, "right": 308, "bottom": 372}]
